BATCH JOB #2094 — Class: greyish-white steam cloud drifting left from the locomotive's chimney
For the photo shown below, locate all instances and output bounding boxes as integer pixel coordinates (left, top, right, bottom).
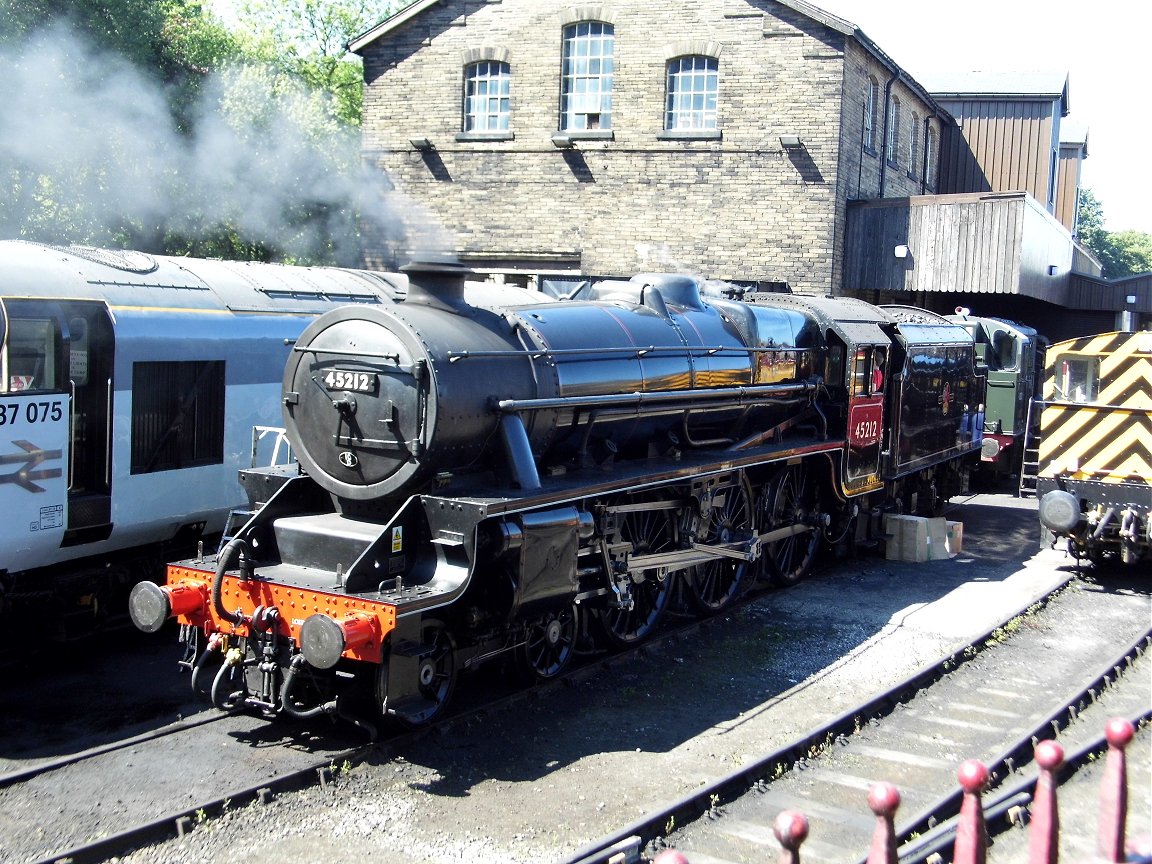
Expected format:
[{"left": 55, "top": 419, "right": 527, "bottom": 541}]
[{"left": 0, "top": 25, "right": 450, "bottom": 266}]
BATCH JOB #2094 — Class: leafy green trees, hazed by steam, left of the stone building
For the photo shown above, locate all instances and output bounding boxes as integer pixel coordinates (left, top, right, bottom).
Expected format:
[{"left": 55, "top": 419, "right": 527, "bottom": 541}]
[{"left": 0, "top": 0, "right": 403, "bottom": 265}]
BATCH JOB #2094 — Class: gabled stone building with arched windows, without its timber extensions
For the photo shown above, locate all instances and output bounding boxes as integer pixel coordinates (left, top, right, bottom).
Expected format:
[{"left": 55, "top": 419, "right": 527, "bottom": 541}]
[{"left": 351, "top": 0, "right": 952, "bottom": 293}]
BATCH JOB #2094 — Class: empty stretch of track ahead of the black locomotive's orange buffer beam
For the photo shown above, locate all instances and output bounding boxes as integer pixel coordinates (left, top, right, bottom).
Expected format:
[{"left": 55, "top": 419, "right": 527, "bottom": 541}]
[{"left": 0, "top": 713, "right": 363, "bottom": 864}]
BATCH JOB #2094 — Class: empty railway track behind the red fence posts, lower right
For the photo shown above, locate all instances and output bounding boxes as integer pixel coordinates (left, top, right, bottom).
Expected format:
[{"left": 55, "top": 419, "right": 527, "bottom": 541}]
[{"left": 566, "top": 589, "right": 1152, "bottom": 864}]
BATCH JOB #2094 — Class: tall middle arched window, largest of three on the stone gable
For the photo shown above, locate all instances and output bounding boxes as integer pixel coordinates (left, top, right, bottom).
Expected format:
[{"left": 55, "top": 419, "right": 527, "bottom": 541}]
[{"left": 560, "top": 21, "right": 615, "bottom": 130}]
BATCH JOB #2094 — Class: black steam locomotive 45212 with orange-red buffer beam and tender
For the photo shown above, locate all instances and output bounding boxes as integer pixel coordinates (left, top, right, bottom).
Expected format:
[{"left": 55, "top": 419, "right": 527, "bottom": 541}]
[{"left": 131, "top": 266, "right": 985, "bottom": 725}]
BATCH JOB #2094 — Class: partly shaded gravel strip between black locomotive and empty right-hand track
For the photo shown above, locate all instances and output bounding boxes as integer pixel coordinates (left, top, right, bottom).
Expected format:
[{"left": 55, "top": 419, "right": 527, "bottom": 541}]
[{"left": 92, "top": 497, "right": 1149, "bottom": 864}]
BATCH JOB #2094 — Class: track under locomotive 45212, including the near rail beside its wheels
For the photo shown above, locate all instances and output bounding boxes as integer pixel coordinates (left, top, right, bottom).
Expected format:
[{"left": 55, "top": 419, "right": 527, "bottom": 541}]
[{"left": 0, "top": 594, "right": 792, "bottom": 864}]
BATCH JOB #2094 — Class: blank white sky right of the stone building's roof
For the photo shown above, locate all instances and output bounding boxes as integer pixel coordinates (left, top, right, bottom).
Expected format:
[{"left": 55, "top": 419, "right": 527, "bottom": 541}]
[{"left": 809, "top": 0, "right": 1152, "bottom": 234}]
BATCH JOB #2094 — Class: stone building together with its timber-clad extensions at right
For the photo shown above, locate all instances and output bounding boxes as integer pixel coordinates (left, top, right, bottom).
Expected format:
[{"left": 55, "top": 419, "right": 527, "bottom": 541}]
[{"left": 350, "top": 0, "right": 1152, "bottom": 338}]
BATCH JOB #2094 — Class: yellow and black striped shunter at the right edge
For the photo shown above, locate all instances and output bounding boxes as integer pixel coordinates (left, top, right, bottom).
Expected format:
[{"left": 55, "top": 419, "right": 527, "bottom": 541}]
[{"left": 1037, "top": 332, "right": 1152, "bottom": 563}]
